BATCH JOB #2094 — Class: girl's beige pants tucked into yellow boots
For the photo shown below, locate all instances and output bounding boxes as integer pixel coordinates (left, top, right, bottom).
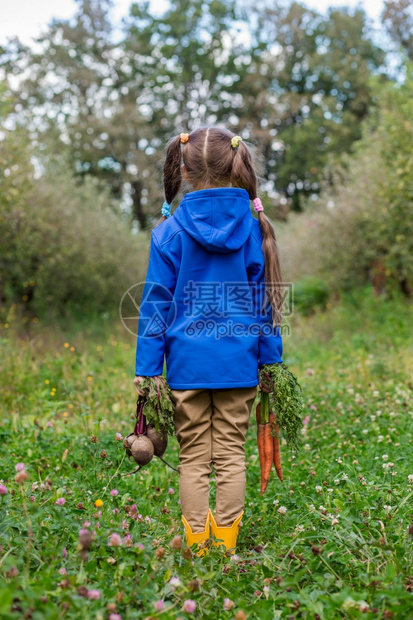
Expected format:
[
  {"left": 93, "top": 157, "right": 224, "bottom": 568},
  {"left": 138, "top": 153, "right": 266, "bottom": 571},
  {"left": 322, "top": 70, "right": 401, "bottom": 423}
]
[{"left": 172, "top": 386, "right": 257, "bottom": 533}]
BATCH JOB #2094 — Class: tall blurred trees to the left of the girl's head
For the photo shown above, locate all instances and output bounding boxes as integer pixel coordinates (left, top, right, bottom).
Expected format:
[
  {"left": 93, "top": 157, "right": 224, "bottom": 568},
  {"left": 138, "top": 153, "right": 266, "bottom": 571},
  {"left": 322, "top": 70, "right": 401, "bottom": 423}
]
[{"left": 0, "top": 0, "right": 241, "bottom": 229}]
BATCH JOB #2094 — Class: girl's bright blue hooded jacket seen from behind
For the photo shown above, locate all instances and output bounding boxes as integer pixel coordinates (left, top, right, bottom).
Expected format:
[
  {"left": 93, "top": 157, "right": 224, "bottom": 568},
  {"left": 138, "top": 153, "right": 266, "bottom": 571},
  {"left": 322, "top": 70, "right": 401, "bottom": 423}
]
[{"left": 135, "top": 187, "right": 282, "bottom": 390}]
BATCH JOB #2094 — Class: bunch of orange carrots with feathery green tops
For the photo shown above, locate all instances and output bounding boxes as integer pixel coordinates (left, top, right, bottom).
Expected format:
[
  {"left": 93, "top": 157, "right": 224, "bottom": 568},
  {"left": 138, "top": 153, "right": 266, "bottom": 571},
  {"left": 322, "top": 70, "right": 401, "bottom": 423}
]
[{"left": 256, "top": 363, "right": 303, "bottom": 495}]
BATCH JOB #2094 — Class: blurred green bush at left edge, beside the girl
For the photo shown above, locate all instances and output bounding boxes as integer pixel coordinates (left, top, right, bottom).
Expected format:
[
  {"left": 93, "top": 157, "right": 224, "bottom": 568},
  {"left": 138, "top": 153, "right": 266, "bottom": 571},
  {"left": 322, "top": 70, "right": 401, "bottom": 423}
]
[{"left": 0, "top": 130, "right": 148, "bottom": 317}]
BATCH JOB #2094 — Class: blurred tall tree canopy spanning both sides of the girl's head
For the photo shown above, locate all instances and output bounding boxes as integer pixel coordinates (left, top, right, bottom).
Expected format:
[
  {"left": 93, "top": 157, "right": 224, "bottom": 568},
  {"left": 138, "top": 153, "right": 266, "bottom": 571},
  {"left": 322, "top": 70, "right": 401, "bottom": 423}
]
[{"left": 0, "top": 0, "right": 384, "bottom": 223}]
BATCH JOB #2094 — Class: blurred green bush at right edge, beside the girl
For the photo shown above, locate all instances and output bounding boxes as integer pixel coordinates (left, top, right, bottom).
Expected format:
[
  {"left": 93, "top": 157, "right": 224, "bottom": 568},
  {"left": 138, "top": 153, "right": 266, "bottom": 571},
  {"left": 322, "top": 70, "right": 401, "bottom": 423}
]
[{"left": 281, "top": 67, "right": 413, "bottom": 295}]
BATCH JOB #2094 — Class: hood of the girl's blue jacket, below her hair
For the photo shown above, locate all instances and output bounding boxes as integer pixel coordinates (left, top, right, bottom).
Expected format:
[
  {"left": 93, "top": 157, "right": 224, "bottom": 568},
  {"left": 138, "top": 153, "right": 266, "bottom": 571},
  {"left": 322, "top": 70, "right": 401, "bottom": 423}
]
[{"left": 174, "top": 187, "right": 254, "bottom": 254}]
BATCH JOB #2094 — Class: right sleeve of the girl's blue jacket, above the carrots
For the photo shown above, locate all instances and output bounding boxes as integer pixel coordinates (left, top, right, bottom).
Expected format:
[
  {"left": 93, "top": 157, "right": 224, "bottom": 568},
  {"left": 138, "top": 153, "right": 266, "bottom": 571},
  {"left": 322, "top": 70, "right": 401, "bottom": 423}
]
[{"left": 248, "top": 246, "right": 283, "bottom": 367}]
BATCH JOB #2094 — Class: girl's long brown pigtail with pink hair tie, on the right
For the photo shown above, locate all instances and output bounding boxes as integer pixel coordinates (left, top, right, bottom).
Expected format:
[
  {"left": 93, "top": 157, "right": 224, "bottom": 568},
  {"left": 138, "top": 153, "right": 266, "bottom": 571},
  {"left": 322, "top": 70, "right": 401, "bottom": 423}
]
[{"left": 231, "top": 136, "right": 283, "bottom": 326}]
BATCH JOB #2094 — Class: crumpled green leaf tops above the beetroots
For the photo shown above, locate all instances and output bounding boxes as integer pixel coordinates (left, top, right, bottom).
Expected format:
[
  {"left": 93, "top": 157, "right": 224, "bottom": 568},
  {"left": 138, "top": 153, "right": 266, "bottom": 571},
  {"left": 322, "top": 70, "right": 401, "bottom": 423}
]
[{"left": 139, "top": 377, "right": 175, "bottom": 436}]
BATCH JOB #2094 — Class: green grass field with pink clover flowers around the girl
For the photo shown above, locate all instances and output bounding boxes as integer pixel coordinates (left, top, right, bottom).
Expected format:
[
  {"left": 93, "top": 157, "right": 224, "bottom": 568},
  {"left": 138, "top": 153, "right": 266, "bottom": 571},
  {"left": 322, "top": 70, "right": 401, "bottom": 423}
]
[{"left": 0, "top": 291, "right": 413, "bottom": 620}]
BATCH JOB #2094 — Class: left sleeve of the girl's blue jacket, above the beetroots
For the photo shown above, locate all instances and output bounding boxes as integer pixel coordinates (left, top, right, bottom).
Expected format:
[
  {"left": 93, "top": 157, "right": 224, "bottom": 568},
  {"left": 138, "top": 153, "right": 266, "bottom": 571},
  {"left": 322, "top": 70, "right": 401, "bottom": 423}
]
[{"left": 135, "top": 231, "right": 176, "bottom": 377}]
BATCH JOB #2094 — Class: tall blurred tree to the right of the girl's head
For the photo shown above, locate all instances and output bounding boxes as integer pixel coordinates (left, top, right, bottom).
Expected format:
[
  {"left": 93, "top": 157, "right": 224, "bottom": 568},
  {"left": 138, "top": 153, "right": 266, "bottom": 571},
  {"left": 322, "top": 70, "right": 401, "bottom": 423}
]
[{"left": 225, "top": 2, "right": 384, "bottom": 209}]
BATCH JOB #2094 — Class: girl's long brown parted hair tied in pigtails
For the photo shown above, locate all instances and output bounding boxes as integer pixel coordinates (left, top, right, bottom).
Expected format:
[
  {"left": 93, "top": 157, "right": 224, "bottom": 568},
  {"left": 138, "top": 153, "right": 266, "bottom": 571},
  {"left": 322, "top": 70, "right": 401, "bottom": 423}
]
[{"left": 159, "top": 127, "right": 283, "bottom": 326}]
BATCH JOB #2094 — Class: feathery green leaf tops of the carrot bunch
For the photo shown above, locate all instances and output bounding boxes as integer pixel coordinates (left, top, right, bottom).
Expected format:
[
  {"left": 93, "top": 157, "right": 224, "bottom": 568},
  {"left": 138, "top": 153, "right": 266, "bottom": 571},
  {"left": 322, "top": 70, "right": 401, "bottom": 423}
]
[{"left": 259, "top": 364, "right": 304, "bottom": 450}]
